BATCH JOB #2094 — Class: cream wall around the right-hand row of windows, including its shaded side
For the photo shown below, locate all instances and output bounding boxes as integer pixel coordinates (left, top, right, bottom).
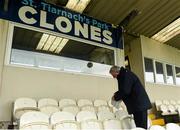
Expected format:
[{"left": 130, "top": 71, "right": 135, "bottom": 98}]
[{"left": 125, "top": 36, "right": 180, "bottom": 102}]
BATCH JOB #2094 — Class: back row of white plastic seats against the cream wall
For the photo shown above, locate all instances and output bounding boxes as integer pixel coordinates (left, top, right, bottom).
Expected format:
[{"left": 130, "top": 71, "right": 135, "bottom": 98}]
[{"left": 13, "top": 98, "right": 122, "bottom": 120}]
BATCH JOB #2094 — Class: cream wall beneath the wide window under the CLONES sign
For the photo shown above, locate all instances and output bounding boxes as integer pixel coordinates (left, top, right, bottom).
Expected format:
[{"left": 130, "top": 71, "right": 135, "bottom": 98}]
[{"left": 0, "top": 20, "right": 124, "bottom": 121}]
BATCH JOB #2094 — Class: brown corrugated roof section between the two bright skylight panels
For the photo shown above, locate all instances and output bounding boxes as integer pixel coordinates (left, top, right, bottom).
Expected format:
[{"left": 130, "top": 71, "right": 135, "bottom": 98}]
[{"left": 84, "top": 0, "right": 180, "bottom": 49}]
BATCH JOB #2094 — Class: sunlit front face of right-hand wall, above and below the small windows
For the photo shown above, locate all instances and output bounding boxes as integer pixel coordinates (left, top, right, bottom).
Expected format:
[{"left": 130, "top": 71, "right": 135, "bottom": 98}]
[{"left": 141, "top": 36, "right": 180, "bottom": 101}]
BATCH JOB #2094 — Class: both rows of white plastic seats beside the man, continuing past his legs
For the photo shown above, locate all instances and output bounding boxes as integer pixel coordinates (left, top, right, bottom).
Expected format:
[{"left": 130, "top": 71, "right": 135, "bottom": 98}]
[{"left": 13, "top": 98, "right": 180, "bottom": 130}]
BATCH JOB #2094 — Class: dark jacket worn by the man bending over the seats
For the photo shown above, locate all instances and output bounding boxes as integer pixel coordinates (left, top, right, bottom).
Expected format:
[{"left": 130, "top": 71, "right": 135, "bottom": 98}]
[{"left": 114, "top": 67, "right": 151, "bottom": 114}]
